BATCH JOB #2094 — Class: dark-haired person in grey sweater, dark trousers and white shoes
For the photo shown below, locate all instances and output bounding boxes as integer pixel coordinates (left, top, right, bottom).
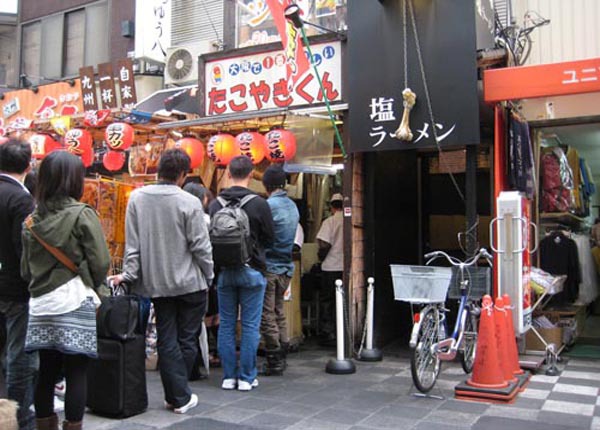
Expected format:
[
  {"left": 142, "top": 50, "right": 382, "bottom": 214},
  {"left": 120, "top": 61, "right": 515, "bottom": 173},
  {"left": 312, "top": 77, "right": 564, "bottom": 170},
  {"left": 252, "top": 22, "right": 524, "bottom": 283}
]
[{"left": 112, "top": 149, "right": 214, "bottom": 414}]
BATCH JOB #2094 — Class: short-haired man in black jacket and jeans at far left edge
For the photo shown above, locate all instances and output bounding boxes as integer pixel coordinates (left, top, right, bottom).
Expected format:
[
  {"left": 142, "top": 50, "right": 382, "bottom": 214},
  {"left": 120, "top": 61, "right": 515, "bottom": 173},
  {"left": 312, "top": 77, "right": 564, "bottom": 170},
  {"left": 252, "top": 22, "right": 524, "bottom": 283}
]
[{"left": 0, "top": 139, "right": 38, "bottom": 429}]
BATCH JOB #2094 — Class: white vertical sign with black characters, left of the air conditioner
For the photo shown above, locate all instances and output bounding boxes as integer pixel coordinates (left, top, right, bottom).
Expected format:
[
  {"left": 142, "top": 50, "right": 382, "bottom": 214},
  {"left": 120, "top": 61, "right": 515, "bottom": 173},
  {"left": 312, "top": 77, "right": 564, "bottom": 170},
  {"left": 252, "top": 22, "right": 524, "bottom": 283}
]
[{"left": 135, "top": 0, "right": 171, "bottom": 62}]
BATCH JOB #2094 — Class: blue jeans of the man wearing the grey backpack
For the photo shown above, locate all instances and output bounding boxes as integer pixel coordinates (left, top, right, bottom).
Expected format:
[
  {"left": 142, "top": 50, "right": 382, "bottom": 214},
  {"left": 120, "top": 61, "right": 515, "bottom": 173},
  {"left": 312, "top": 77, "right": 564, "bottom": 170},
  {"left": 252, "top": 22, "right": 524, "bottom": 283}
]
[{"left": 217, "top": 267, "right": 267, "bottom": 383}]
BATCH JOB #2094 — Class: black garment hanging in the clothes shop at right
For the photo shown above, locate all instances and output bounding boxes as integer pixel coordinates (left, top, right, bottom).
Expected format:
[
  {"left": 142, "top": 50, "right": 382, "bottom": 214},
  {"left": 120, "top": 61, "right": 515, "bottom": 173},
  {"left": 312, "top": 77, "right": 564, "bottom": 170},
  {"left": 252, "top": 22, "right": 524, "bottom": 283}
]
[{"left": 540, "top": 231, "right": 581, "bottom": 305}]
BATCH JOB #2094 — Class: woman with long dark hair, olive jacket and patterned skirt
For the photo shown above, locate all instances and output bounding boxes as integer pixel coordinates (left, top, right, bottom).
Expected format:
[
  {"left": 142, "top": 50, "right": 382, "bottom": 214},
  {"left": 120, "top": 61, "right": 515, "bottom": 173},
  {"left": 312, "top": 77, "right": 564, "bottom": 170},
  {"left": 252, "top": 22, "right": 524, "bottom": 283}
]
[{"left": 21, "top": 151, "right": 110, "bottom": 430}]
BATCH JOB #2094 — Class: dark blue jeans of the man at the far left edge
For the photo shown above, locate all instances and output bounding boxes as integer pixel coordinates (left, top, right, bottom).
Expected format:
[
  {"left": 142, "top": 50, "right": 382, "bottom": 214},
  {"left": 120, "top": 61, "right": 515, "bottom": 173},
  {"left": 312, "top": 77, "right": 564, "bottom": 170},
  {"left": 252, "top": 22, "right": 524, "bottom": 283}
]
[{"left": 0, "top": 301, "right": 38, "bottom": 430}]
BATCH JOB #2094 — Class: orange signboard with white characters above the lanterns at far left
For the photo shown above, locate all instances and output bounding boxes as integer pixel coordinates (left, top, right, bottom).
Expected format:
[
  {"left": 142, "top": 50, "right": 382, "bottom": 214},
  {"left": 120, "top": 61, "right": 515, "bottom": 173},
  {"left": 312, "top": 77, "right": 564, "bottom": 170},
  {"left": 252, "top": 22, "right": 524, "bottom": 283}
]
[{"left": 0, "top": 79, "right": 83, "bottom": 136}]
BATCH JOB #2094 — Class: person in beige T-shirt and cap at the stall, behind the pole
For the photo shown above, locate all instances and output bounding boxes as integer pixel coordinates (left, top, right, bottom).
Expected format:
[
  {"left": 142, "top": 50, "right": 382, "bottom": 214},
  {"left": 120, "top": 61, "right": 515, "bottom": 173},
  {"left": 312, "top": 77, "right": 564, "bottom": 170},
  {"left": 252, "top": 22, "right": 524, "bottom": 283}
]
[{"left": 317, "top": 193, "right": 344, "bottom": 342}]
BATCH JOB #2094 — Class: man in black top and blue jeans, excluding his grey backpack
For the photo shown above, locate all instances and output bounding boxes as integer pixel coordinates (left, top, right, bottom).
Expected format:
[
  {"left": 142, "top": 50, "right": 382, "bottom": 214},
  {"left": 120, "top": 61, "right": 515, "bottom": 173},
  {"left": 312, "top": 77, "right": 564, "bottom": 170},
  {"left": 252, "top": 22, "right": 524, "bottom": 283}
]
[{"left": 209, "top": 155, "right": 273, "bottom": 391}]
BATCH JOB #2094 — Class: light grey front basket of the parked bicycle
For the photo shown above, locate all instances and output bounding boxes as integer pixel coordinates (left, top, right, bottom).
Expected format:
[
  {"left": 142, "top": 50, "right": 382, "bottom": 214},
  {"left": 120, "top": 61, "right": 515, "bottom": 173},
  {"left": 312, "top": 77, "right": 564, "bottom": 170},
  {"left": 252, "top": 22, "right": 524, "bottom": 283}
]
[{"left": 390, "top": 264, "right": 452, "bottom": 303}]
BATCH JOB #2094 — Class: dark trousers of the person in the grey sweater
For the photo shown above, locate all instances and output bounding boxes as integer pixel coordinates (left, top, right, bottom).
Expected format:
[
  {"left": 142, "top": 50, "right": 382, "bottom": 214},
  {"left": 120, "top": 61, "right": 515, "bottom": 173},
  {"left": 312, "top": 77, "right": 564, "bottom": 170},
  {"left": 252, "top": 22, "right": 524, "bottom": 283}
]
[{"left": 154, "top": 291, "right": 206, "bottom": 408}]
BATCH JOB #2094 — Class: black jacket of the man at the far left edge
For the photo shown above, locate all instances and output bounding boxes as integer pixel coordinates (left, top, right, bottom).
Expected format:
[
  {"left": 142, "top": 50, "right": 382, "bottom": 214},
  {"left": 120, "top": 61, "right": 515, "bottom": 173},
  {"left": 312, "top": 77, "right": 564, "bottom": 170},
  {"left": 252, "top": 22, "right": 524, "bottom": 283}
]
[{"left": 0, "top": 176, "right": 34, "bottom": 302}]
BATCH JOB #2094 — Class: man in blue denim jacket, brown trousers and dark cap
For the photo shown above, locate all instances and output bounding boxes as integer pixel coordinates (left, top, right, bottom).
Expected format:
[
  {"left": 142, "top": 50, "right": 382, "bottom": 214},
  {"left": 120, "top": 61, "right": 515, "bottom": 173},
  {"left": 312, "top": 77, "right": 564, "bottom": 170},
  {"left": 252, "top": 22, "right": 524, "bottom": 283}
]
[{"left": 260, "top": 164, "right": 300, "bottom": 376}]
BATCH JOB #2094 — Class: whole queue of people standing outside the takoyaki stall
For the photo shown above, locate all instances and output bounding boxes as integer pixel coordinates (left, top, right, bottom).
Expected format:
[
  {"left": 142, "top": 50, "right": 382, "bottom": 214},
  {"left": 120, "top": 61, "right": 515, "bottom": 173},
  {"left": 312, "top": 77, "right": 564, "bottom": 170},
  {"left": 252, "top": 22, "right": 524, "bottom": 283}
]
[{"left": 0, "top": 139, "right": 341, "bottom": 430}]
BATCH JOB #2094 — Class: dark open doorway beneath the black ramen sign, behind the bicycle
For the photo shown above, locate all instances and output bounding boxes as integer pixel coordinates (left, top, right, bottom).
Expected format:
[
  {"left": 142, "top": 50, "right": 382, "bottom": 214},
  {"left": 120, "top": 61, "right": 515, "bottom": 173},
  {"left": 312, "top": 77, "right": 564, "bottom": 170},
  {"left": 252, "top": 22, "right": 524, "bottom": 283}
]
[{"left": 365, "top": 145, "right": 492, "bottom": 347}]
